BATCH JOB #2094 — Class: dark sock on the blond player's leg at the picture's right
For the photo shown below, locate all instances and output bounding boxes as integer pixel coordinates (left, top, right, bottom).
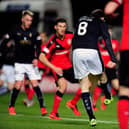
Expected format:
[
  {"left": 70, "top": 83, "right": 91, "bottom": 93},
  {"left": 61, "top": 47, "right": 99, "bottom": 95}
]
[{"left": 33, "top": 86, "right": 44, "bottom": 108}]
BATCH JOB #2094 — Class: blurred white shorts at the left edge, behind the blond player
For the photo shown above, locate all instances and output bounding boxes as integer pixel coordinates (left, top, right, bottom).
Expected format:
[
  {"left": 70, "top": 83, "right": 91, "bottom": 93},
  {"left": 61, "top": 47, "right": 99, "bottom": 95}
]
[{"left": 0, "top": 65, "right": 15, "bottom": 83}]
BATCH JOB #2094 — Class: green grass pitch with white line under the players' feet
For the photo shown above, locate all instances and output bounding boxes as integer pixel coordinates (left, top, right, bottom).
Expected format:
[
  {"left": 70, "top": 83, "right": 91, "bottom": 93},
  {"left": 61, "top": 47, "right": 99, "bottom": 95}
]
[{"left": 0, "top": 93, "right": 118, "bottom": 129}]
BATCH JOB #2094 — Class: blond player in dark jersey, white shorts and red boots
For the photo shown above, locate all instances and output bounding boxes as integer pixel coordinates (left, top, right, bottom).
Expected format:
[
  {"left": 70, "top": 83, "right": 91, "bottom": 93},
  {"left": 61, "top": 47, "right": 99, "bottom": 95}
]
[{"left": 2, "top": 10, "right": 47, "bottom": 115}]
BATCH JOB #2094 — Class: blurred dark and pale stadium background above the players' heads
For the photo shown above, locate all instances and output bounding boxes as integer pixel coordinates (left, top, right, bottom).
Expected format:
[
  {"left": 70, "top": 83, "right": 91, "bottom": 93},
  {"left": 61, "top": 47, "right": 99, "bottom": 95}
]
[{"left": 0, "top": 0, "right": 122, "bottom": 37}]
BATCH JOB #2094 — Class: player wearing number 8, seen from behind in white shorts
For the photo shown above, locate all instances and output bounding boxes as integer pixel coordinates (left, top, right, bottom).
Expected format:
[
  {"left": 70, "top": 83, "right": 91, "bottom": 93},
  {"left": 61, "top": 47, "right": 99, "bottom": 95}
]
[{"left": 72, "top": 9, "right": 116, "bottom": 126}]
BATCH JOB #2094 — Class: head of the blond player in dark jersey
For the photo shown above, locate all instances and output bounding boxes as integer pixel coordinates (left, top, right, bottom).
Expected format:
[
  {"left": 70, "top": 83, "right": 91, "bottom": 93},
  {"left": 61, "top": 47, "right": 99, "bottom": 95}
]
[{"left": 21, "top": 10, "right": 34, "bottom": 29}]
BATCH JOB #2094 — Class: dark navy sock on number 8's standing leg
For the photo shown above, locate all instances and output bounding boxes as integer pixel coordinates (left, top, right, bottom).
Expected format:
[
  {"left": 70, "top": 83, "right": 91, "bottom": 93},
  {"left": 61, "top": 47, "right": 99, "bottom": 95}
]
[{"left": 81, "top": 92, "right": 95, "bottom": 120}]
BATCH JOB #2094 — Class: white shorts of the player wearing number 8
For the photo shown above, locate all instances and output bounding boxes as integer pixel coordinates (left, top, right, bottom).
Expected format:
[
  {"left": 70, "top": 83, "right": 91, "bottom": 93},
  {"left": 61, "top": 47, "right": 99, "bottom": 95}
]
[{"left": 73, "top": 49, "right": 104, "bottom": 79}]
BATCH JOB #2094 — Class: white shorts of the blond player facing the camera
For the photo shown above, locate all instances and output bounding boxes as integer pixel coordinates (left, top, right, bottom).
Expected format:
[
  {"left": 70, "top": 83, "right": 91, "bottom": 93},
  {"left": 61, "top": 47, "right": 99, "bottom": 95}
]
[{"left": 15, "top": 63, "right": 41, "bottom": 80}]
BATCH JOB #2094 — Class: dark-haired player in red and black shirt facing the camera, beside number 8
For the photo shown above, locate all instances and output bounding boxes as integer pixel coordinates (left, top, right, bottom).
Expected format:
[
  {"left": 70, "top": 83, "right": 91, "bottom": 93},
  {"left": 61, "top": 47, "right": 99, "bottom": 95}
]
[{"left": 39, "top": 18, "right": 81, "bottom": 119}]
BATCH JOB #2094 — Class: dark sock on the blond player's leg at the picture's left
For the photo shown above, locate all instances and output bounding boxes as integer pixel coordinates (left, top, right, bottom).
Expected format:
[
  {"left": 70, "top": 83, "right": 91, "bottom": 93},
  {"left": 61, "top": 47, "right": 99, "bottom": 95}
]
[{"left": 9, "top": 88, "right": 20, "bottom": 107}]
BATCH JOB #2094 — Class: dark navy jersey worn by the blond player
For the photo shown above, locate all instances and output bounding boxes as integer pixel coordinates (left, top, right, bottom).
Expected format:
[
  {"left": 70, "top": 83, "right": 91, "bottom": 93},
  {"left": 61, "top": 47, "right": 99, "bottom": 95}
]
[{"left": 2, "top": 25, "right": 41, "bottom": 63}]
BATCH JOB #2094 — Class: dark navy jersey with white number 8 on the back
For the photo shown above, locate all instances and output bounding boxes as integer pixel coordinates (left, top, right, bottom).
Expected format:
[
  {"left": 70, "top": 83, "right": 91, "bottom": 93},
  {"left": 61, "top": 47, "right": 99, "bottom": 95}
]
[{"left": 72, "top": 15, "right": 116, "bottom": 62}]
